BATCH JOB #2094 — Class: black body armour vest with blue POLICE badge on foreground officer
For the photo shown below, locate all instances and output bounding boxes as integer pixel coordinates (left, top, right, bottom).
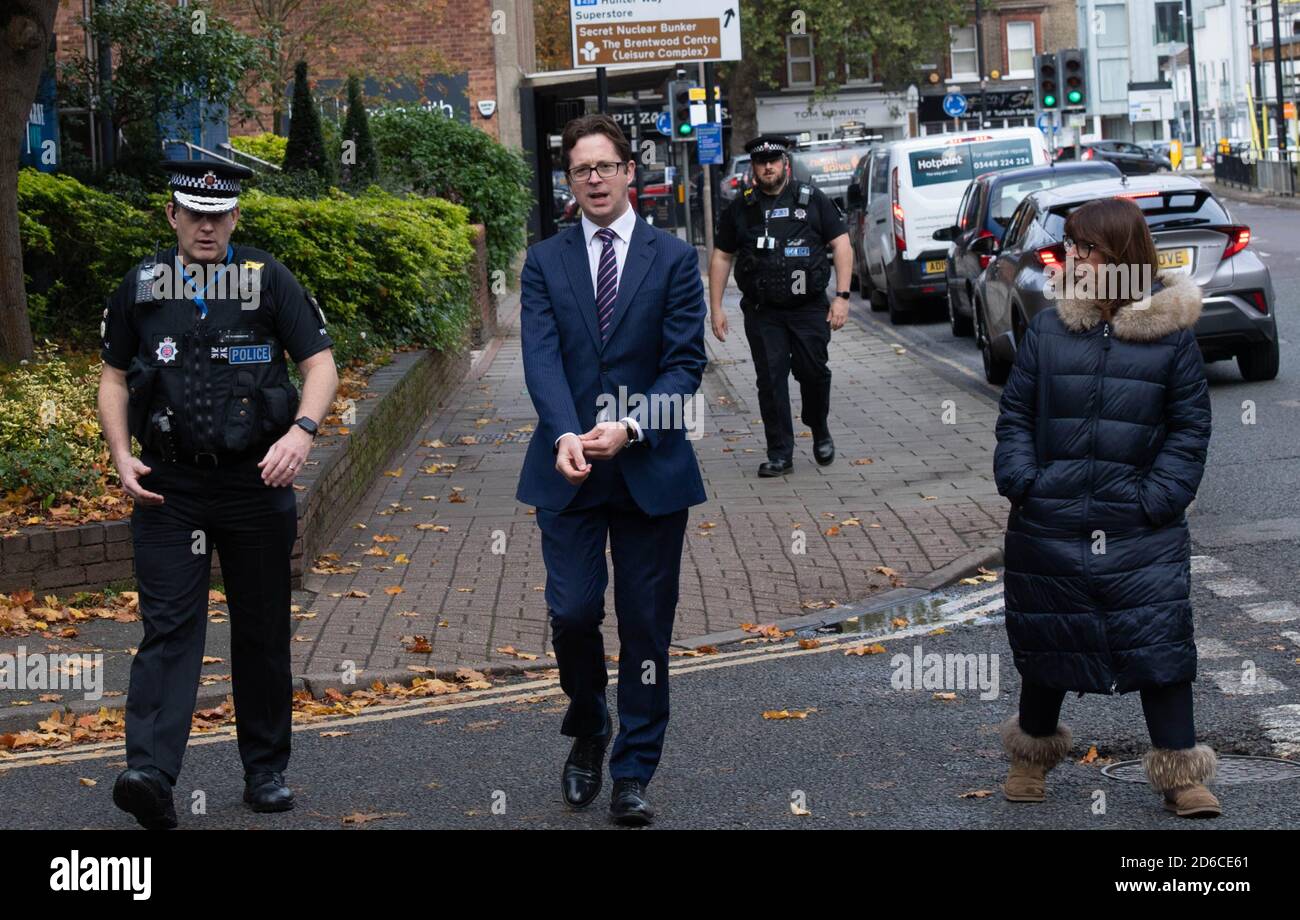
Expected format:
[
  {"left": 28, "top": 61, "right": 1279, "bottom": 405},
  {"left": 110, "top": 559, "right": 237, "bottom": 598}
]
[{"left": 126, "top": 251, "right": 298, "bottom": 456}]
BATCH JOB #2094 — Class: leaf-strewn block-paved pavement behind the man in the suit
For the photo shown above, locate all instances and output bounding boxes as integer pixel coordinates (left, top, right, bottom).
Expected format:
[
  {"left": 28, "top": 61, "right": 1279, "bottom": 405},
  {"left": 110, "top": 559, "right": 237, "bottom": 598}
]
[{"left": 293, "top": 272, "right": 1008, "bottom": 680}]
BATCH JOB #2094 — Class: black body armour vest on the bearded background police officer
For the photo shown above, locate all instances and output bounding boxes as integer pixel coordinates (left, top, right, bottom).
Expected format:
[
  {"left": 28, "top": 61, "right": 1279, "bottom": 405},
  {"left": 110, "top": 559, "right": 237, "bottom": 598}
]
[{"left": 736, "top": 182, "right": 831, "bottom": 308}]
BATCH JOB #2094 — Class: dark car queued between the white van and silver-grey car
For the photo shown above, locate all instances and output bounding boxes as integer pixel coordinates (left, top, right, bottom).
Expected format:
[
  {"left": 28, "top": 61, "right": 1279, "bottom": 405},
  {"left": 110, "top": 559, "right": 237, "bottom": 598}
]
[{"left": 933, "top": 161, "right": 1121, "bottom": 337}]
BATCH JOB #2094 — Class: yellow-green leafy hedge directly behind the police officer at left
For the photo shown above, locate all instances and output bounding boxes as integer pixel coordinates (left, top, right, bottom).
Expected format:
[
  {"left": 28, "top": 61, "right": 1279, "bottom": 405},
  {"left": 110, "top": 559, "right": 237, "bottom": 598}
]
[{"left": 18, "top": 169, "right": 473, "bottom": 360}]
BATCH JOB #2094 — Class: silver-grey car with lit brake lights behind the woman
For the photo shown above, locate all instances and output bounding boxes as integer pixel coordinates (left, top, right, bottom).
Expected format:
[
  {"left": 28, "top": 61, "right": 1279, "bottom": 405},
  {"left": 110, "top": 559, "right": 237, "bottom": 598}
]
[{"left": 970, "top": 175, "right": 1279, "bottom": 383}]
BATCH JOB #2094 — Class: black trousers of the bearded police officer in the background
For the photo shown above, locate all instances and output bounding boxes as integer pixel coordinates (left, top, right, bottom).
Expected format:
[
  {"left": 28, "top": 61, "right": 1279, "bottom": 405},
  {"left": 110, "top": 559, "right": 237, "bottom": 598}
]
[{"left": 741, "top": 300, "right": 831, "bottom": 463}]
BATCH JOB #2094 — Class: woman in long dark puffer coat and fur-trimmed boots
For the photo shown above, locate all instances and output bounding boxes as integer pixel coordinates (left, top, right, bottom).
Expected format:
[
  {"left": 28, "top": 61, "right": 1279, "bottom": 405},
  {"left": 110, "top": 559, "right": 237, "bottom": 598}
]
[{"left": 993, "top": 199, "right": 1219, "bottom": 816}]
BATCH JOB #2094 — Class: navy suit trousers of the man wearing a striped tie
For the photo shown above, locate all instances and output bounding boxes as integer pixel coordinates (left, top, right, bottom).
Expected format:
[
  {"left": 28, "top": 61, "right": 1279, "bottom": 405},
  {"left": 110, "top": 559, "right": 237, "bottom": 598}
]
[{"left": 537, "top": 467, "right": 688, "bottom": 784}]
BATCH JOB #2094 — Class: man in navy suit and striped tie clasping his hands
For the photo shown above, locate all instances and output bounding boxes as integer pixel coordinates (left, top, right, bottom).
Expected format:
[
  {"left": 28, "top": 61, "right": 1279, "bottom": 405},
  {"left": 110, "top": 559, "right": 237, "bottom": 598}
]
[{"left": 517, "top": 114, "right": 707, "bottom": 825}]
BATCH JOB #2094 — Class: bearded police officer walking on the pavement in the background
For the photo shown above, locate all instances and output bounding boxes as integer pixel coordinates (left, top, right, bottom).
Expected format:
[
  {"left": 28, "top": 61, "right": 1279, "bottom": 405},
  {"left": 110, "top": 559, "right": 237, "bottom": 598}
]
[{"left": 709, "top": 134, "right": 853, "bottom": 477}]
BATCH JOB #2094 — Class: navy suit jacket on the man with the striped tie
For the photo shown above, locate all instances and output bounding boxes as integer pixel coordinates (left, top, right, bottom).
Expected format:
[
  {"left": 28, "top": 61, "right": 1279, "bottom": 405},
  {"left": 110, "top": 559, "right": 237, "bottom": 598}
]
[{"left": 516, "top": 217, "right": 707, "bottom": 516}]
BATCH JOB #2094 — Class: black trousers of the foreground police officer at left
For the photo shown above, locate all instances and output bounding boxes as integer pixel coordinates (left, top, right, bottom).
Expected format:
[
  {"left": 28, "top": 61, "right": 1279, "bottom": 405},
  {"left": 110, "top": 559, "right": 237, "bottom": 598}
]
[{"left": 126, "top": 452, "right": 298, "bottom": 784}]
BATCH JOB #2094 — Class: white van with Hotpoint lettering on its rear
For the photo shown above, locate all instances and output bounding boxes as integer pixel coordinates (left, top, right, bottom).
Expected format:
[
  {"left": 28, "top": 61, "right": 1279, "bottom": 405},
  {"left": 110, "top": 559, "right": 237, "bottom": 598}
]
[{"left": 849, "top": 127, "right": 1049, "bottom": 322}]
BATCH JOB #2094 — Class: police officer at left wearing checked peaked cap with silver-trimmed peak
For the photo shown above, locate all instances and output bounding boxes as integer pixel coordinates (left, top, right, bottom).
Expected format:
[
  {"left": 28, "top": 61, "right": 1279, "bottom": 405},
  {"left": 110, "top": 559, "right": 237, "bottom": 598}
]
[{"left": 99, "top": 161, "right": 338, "bottom": 828}]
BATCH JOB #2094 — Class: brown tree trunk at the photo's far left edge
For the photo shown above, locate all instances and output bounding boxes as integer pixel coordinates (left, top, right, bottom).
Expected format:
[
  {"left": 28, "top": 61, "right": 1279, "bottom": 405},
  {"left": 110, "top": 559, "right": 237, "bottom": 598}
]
[{"left": 0, "top": 0, "right": 59, "bottom": 361}]
